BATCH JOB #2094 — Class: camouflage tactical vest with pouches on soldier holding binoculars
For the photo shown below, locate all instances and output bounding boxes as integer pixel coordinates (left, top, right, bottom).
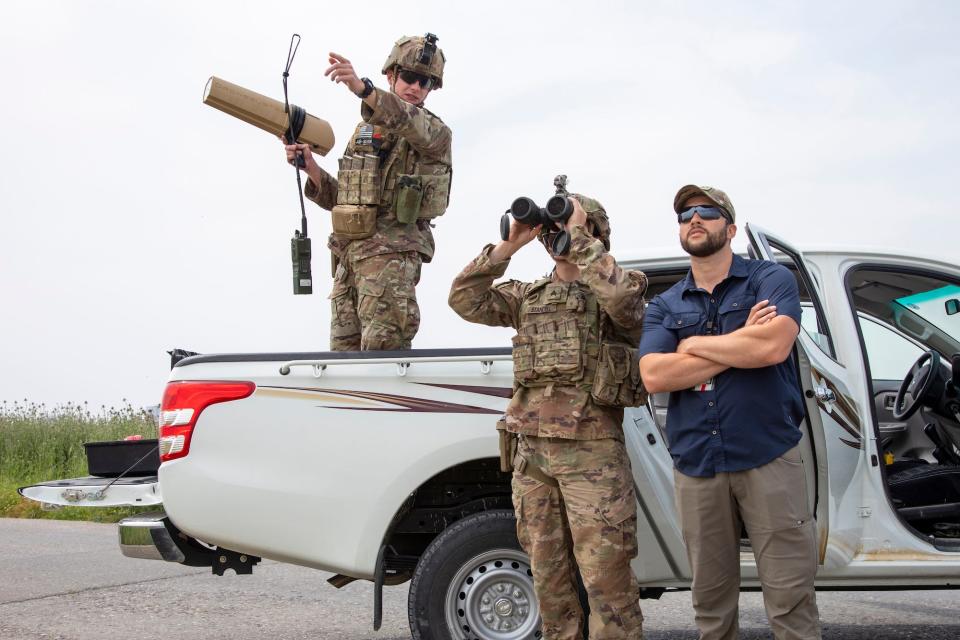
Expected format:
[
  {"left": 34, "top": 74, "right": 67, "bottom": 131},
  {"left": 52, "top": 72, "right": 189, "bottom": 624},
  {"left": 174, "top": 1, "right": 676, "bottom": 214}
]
[{"left": 513, "top": 278, "right": 646, "bottom": 407}]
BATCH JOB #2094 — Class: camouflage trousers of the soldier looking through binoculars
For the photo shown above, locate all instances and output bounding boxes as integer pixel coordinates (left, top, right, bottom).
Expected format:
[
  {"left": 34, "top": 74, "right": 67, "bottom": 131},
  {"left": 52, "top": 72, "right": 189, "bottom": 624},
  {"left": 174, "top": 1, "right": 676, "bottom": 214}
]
[{"left": 513, "top": 436, "right": 643, "bottom": 640}]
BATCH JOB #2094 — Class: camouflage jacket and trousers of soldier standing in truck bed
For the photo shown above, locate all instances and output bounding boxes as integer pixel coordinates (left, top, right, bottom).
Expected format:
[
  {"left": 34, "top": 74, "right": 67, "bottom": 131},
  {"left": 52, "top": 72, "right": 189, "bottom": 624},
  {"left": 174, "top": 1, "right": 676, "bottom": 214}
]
[{"left": 304, "top": 40, "right": 452, "bottom": 351}]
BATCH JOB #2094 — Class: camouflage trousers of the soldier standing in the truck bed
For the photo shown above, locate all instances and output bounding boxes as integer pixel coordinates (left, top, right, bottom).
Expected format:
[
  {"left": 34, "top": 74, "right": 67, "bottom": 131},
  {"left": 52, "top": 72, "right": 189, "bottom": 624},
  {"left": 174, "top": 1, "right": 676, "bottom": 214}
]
[{"left": 330, "top": 251, "right": 422, "bottom": 351}]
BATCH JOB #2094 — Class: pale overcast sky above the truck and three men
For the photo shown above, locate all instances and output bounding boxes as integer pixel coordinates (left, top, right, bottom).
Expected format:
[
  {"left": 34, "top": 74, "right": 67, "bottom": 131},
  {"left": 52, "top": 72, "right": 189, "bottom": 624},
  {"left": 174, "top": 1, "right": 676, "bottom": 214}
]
[{"left": 0, "top": 0, "right": 960, "bottom": 406}]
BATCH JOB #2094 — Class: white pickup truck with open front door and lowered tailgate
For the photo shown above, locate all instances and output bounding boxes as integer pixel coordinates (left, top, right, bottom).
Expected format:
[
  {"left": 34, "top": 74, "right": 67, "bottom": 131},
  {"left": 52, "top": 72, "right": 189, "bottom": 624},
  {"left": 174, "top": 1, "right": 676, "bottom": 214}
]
[{"left": 21, "top": 225, "right": 960, "bottom": 640}]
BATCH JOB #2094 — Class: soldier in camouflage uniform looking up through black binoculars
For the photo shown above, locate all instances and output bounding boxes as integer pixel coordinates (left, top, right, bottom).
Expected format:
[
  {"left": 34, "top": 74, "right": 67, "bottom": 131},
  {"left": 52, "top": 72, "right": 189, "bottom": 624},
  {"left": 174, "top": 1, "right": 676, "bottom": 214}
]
[{"left": 449, "top": 195, "right": 647, "bottom": 640}]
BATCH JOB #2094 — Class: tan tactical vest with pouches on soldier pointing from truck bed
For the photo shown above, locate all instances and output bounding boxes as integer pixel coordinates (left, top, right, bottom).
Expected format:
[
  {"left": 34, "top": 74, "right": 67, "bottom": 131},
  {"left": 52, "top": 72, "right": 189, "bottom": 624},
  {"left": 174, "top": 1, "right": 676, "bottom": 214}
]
[{"left": 333, "top": 122, "right": 451, "bottom": 240}]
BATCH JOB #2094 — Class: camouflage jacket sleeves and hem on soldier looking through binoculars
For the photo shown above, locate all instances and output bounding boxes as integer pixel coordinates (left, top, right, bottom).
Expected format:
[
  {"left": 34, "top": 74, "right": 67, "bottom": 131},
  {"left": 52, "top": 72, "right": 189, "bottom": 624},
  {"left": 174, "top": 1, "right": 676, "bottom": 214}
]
[{"left": 449, "top": 226, "right": 647, "bottom": 440}]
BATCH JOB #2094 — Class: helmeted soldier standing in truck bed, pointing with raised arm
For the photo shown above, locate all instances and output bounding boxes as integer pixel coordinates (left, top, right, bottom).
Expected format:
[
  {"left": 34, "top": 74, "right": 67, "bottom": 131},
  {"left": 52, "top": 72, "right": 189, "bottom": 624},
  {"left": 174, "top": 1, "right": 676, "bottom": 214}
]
[{"left": 286, "top": 34, "right": 452, "bottom": 351}]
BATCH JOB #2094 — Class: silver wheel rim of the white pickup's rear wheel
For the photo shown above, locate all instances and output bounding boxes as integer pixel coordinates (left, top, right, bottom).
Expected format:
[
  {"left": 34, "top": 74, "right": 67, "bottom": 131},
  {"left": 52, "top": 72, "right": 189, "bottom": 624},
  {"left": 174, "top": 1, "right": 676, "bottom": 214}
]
[{"left": 445, "top": 549, "right": 540, "bottom": 640}]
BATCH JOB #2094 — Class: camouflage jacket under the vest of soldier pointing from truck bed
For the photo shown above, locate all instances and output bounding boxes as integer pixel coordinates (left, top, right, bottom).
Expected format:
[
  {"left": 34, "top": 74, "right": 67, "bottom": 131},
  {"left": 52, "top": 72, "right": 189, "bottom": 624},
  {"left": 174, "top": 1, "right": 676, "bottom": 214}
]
[{"left": 304, "top": 89, "right": 453, "bottom": 262}]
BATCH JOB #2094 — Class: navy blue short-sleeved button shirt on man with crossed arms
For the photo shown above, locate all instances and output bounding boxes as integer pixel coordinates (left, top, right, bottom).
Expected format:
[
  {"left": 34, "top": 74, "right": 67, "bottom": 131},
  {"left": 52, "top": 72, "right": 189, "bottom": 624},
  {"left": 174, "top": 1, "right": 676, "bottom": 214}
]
[{"left": 640, "top": 255, "right": 804, "bottom": 477}]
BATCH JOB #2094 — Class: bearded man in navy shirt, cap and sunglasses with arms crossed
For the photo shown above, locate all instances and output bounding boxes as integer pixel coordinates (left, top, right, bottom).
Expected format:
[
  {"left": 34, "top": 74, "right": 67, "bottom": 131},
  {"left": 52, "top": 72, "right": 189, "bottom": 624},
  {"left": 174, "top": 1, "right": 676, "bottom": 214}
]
[{"left": 640, "top": 185, "right": 820, "bottom": 640}]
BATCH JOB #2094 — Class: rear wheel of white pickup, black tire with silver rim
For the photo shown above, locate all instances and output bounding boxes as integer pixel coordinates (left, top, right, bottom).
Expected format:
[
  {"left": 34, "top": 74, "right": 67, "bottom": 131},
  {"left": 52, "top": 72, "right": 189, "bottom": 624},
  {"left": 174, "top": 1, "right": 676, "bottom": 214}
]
[{"left": 407, "top": 510, "right": 541, "bottom": 640}]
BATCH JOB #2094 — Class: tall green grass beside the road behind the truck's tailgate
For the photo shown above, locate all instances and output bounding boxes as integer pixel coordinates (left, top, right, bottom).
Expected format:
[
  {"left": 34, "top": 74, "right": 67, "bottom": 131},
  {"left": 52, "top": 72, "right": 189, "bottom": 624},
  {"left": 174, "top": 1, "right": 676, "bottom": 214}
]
[{"left": 0, "top": 400, "right": 157, "bottom": 522}]
